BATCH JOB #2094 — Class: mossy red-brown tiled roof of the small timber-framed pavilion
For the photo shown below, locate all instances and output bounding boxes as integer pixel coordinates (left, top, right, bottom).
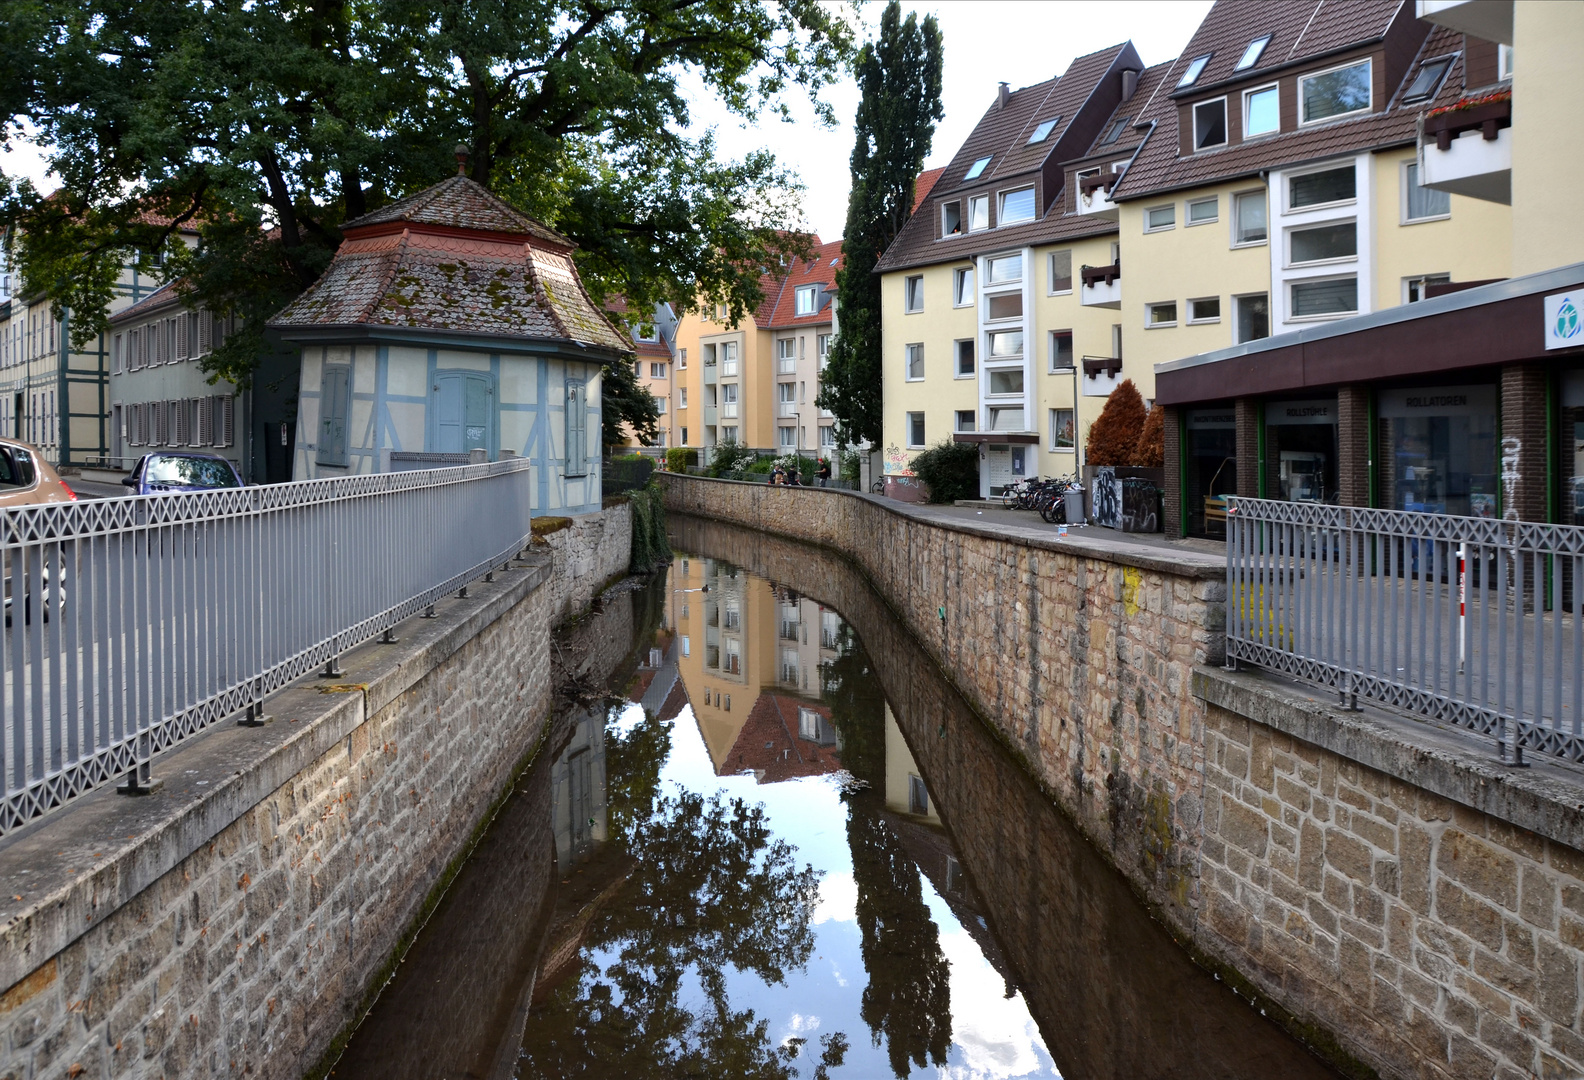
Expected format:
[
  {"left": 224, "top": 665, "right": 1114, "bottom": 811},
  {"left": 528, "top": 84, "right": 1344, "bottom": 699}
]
[{"left": 269, "top": 177, "right": 632, "bottom": 353}]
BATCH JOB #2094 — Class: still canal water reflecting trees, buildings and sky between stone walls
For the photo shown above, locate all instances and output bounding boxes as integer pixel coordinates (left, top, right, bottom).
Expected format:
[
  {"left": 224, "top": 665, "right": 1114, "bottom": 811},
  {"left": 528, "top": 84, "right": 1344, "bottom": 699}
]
[{"left": 331, "top": 519, "right": 1334, "bottom": 1080}]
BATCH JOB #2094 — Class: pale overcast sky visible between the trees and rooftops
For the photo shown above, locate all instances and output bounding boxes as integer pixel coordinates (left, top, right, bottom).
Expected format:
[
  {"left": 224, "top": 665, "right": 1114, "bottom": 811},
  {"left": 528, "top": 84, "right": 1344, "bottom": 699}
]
[{"left": 0, "top": 0, "right": 1210, "bottom": 241}]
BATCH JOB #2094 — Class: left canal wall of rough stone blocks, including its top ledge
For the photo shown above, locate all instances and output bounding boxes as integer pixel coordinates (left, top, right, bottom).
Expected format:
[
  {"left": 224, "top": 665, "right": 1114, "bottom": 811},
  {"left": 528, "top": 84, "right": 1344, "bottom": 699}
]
[{"left": 0, "top": 508, "right": 629, "bottom": 1080}]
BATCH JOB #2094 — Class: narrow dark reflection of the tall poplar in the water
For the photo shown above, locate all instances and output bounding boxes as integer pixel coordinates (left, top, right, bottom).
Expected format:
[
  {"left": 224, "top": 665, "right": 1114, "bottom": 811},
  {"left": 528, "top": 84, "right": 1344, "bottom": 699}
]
[{"left": 821, "top": 624, "right": 952, "bottom": 1077}]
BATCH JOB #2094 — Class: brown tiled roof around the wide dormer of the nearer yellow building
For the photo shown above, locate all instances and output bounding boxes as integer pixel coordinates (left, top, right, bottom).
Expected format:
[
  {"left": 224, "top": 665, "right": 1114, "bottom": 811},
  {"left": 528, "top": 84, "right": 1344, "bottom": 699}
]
[{"left": 1112, "top": 19, "right": 1464, "bottom": 200}]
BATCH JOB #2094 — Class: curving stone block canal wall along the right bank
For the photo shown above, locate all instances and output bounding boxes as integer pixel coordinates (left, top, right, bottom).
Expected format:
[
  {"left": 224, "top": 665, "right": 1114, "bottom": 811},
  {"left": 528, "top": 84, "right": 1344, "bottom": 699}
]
[{"left": 664, "top": 477, "right": 1584, "bottom": 1080}]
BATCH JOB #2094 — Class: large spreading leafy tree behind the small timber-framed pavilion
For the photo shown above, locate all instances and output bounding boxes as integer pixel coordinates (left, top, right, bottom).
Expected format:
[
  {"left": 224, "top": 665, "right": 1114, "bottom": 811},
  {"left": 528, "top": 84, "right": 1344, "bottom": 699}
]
[{"left": 0, "top": 0, "right": 852, "bottom": 383}]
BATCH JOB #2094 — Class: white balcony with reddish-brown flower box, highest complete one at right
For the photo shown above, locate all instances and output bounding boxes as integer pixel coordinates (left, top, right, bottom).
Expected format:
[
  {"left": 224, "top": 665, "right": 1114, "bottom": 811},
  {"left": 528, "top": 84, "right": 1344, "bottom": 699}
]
[{"left": 1419, "top": 90, "right": 1513, "bottom": 206}]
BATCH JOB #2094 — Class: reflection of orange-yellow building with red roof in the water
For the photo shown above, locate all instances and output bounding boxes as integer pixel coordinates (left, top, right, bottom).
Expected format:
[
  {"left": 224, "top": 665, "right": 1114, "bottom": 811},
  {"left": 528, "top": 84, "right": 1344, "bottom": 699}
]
[{"left": 668, "top": 556, "right": 841, "bottom": 784}]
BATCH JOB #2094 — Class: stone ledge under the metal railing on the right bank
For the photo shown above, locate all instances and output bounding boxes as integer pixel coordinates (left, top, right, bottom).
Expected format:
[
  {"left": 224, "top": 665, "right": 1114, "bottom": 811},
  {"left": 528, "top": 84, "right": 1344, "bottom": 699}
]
[{"left": 1193, "top": 667, "right": 1584, "bottom": 850}]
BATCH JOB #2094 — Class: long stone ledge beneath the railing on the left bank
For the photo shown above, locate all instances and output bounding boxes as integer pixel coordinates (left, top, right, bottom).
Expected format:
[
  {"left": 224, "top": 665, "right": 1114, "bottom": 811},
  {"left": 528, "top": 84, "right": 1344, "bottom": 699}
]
[{"left": 0, "top": 559, "right": 550, "bottom": 988}]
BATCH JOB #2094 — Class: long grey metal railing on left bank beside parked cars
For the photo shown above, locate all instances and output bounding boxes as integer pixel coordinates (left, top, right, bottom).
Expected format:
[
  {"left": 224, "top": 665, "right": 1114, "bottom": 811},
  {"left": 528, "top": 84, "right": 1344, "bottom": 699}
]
[{"left": 0, "top": 459, "right": 531, "bottom": 833}]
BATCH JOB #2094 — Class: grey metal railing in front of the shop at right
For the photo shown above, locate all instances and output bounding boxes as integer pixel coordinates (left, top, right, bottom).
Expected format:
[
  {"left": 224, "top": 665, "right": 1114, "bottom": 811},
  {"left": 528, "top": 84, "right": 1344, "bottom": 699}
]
[{"left": 1226, "top": 499, "right": 1584, "bottom": 763}]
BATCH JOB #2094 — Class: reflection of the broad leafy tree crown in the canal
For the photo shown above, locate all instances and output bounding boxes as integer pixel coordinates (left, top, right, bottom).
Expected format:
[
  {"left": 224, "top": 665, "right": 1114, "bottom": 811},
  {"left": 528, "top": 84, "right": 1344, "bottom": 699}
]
[{"left": 521, "top": 714, "right": 846, "bottom": 1080}]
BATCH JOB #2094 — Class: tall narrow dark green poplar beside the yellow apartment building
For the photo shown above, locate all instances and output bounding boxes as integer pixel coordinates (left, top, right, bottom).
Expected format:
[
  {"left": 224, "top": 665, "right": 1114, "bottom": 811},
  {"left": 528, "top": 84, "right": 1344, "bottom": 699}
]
[{"left": 816, "top": 0, "right": 946, "bottom": 445}]
